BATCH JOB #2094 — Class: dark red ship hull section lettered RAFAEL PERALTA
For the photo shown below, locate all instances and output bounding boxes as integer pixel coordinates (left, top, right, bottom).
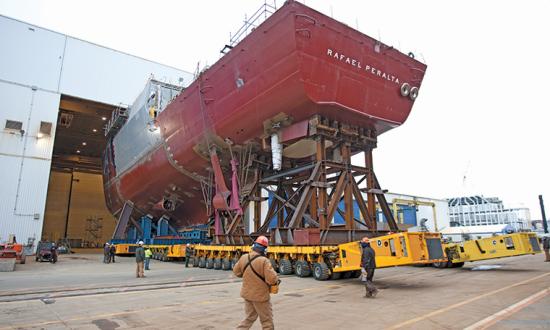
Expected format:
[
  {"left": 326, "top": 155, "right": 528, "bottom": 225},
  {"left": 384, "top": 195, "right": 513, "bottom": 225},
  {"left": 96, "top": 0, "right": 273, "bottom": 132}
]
[{"left": 104, "top": 2, "right": 426, "bottom": 228}]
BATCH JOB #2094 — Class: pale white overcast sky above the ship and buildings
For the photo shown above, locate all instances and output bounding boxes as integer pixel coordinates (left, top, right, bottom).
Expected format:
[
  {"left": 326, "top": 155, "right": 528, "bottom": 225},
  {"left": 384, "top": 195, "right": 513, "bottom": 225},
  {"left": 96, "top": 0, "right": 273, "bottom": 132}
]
[{"left": 0, "top": 0, "right": 550, "bottom": 219}]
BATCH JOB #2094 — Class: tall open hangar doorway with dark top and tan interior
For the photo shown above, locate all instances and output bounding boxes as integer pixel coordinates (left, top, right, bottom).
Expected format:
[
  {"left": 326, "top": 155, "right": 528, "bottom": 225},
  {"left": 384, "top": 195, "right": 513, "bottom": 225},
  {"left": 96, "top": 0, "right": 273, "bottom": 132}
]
[{"left": 42, "top": 96, "right": 119, "bottom": 247}]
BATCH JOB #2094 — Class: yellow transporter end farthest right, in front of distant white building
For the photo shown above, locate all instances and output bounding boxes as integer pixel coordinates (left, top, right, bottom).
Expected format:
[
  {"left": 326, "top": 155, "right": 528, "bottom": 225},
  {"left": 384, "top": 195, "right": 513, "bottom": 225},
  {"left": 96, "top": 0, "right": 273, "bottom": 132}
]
[{"left": 434, "top": 233, "right": 541, "bottom": 268}]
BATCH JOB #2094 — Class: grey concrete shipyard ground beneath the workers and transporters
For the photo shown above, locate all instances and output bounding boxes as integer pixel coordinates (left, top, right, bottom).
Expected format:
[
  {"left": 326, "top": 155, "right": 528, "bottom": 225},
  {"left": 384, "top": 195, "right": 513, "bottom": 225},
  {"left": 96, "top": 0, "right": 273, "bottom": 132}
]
[{"left": 0, "top": 254, "right": 550, "bottom": 330}]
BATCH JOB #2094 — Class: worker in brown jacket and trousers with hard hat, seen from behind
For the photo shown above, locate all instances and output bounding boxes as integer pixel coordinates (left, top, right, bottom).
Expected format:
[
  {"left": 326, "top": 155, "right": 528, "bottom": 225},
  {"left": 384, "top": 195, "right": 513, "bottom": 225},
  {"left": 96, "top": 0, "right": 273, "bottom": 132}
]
[{"left": 233, "top": 236, "right": 279, "bottom": 330}]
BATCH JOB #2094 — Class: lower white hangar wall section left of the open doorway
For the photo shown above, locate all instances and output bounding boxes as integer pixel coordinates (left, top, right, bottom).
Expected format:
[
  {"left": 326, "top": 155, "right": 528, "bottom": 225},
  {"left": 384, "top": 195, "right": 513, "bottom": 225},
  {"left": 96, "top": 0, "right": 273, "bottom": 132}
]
[{"left": 0, "top": 83, "right": 60, "bottom": 250}]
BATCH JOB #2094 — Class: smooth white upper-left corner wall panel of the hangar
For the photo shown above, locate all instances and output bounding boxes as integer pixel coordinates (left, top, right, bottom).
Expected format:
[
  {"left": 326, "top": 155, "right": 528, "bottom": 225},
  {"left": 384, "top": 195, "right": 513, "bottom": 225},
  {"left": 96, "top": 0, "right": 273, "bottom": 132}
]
[{"left": 0, "top": 16, "right": 65, "bottom": 91}]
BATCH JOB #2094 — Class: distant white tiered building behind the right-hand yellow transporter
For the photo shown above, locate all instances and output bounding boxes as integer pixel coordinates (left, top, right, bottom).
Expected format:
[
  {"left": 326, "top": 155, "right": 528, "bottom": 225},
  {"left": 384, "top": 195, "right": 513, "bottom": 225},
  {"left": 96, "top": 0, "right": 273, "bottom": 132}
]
[{"left": 448, "top": 196, "right": 531, "bottom": 231}]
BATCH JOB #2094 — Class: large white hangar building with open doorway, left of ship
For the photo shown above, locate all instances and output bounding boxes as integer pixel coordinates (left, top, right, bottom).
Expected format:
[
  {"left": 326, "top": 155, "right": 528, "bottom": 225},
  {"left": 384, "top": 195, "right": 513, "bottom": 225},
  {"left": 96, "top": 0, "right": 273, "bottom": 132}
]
[{"left": 0, "top": 16, "right": 193, "bottom": 249}]
